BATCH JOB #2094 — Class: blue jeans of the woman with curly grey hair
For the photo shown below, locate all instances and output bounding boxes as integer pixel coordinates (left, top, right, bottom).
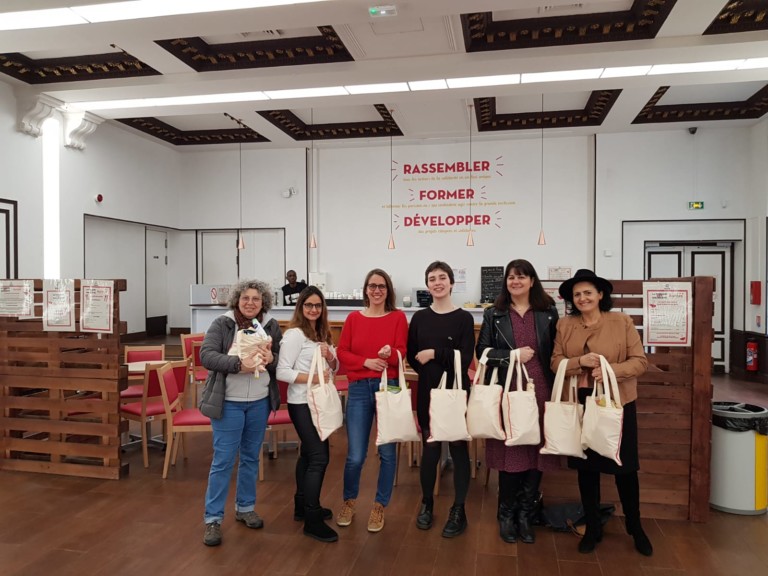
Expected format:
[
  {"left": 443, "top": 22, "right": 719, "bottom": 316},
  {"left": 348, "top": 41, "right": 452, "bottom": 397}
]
[{"left": 204, "top": 398, "right": 269, "bottom": 524}]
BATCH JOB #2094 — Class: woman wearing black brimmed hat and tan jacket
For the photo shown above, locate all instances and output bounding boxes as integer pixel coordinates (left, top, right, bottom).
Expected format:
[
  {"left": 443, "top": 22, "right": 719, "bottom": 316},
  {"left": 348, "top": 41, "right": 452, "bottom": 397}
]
[{"left": 551, "top": 269, "right": 653, "bottom": 556}]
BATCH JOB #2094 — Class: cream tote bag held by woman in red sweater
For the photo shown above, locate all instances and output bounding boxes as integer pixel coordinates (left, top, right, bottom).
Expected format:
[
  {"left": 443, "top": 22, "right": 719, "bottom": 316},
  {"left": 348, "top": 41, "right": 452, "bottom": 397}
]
[{"left": 376, "top": 350, "right": 421, "bottom": 446}]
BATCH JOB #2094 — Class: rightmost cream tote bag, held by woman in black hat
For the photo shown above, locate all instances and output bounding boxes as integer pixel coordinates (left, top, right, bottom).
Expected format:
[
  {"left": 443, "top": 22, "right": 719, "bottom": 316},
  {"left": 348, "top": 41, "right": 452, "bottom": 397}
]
[{"left": 581, "top": 356, "right": 624, "bottom": 466}]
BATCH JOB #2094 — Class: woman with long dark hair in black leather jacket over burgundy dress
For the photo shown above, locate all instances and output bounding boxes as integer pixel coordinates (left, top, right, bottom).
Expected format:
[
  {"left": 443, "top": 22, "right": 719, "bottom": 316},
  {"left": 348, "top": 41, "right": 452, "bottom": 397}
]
[{"left": 477, "top": 260, "right": 560, "bottom": 544}]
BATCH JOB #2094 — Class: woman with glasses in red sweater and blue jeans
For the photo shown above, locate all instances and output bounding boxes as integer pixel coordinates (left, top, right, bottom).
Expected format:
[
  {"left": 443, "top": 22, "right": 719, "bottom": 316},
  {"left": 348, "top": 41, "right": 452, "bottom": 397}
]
[{"left": 336, "top": 268, "right": 408, "bottom": 532}]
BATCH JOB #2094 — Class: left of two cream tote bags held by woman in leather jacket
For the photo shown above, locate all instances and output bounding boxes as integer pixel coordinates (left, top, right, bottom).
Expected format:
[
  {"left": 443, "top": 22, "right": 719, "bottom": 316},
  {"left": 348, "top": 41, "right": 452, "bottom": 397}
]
[{"left": 467, "top": 348, "right": 507, "bottom": 440}]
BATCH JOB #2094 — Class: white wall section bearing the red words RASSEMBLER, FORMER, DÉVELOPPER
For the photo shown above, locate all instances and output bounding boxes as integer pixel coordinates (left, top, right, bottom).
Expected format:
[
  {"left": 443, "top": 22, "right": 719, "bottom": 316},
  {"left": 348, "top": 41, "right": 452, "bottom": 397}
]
[{"left": 317, "top": 138, "right": 591, "bottom": 303}]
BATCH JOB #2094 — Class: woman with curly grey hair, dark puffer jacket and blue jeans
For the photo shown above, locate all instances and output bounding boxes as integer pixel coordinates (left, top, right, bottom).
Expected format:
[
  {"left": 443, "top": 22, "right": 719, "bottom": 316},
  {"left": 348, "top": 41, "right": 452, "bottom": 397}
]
[{"left": 200, "top": 280, "right": 281, "bottom": 546}]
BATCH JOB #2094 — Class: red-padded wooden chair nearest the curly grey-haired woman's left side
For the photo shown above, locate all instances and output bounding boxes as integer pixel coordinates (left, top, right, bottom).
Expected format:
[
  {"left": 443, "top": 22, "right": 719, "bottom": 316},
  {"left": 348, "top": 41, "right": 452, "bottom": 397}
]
[{"left": 158, "top": 361, "right": 213, "bottom": 478}]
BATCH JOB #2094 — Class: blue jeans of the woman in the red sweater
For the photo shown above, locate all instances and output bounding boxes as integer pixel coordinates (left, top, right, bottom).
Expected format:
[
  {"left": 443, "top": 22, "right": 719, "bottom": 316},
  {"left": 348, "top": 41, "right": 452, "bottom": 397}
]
[{"left": 344, "top": 378, "right": 397, "bottom": 506}]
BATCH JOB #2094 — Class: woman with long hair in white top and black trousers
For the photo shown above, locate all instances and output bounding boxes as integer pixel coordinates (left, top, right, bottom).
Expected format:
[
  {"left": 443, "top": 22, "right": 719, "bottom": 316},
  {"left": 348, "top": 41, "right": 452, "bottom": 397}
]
[{"left": 277, "top": 286, "right": 339, "bottom": 542}]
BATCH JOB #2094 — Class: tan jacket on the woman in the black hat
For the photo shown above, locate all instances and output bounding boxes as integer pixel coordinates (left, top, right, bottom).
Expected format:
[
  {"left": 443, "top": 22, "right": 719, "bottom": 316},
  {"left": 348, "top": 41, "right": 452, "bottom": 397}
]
[{"left": 551, "top": 312, "right": 648, "bottom": 404}]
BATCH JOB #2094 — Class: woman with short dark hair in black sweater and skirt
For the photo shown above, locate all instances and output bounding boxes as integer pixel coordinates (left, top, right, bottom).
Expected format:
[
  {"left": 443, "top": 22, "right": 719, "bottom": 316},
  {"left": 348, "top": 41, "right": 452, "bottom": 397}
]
[{"left": 408, "top": 261, "right": 475, "bottom": 538}]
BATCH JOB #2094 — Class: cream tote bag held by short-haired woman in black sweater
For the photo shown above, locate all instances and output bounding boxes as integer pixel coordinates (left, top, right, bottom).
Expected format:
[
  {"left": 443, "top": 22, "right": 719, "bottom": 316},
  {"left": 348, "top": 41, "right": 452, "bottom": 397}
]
[{"left": 427, "top": 350, "right": 472, "bottom": 442}]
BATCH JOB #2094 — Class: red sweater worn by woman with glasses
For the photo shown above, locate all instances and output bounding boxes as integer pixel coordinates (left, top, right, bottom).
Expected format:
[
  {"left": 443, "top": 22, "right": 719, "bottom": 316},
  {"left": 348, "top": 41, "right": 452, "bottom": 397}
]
[{"left": 336, "top": 310, "right": 408, "bottom": 382}]
